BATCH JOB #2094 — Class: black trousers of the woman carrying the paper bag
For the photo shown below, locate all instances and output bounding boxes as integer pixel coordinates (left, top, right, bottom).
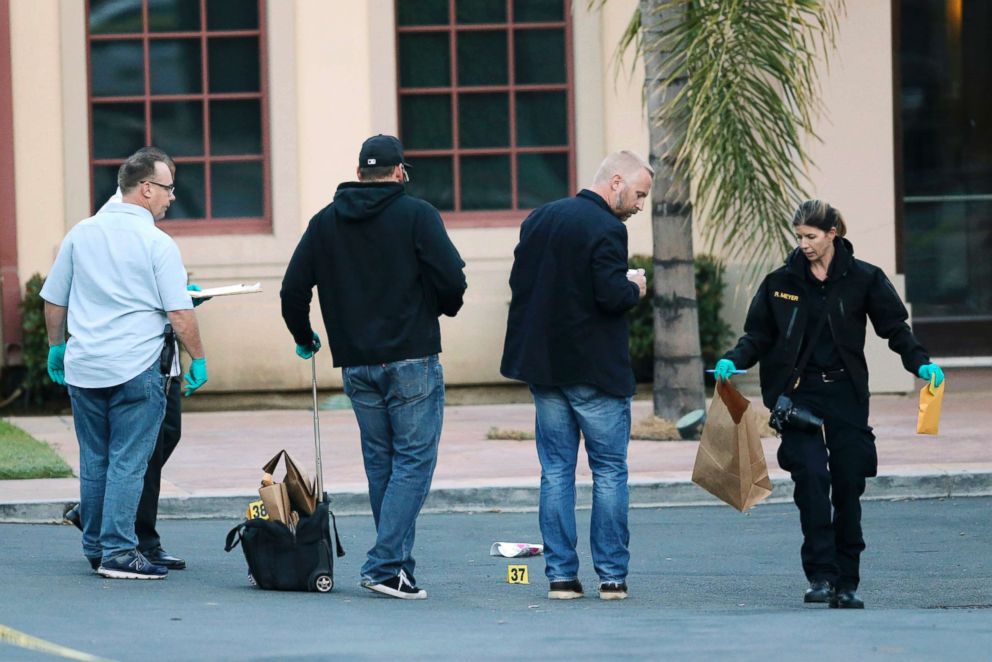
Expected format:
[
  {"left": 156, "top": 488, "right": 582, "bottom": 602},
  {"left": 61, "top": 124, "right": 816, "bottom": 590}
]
[{"left": 778, "top": 376, "right": 878, "bottom": 590}]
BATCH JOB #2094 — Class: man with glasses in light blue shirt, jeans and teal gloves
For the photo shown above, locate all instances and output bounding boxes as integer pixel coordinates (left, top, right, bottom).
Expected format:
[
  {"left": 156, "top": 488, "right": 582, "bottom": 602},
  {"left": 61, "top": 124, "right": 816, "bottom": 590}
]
[{"left": 41, "top": 148, "right": 207, "bottom": 579}]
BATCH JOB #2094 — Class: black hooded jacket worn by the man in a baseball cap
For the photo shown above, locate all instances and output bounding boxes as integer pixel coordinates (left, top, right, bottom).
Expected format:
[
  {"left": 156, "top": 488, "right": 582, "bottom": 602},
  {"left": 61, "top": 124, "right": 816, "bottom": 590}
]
[{"left": 280, "top": 182, "right": 466, "bottom": 366}]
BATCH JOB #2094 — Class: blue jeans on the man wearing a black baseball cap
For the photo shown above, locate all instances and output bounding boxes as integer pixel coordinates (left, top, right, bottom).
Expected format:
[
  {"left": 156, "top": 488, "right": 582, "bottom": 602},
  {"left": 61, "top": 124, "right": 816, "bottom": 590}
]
[{"left": 342, "top": 354, "right": 444, "bottom": 582}]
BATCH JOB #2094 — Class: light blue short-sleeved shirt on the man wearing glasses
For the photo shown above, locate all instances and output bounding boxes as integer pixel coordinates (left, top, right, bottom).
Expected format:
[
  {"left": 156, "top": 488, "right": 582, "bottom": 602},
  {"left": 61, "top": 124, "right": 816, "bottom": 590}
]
[{"left": 41, "top": 203, "right": 193, "bottom": 388}]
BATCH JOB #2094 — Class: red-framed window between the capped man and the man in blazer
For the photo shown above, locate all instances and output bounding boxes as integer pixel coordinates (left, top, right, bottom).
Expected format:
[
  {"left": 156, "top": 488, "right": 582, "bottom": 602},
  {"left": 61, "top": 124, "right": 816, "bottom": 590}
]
[{"left": 396, "top": 0, "right": 575, "bottom": 220}]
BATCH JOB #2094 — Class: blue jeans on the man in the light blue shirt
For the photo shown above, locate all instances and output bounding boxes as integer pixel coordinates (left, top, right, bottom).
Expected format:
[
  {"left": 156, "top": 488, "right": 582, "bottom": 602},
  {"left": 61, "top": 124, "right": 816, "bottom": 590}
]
[{"left": 69, "top": 361, "right": 165, "bottom": 561}]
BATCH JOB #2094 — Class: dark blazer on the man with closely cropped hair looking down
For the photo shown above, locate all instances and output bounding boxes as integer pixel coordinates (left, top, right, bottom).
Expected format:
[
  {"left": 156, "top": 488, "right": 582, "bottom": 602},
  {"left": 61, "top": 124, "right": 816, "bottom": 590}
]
[{"left": 500, "top": 190, "right": 639, "bottom": 397}]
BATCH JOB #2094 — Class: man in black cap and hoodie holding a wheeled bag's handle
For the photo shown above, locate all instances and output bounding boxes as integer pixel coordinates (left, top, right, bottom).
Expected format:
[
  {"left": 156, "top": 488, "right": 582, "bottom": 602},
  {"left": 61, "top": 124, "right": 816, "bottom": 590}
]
[{"left": 281, "top": 134, "right": 466, "bottom": 599}]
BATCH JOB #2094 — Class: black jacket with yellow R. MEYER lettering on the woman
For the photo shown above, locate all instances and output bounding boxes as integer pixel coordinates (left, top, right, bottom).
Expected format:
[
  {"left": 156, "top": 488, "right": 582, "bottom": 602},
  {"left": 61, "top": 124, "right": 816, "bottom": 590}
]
[{"left": 724, "top": 237, "right": 930, "bottom": 408}]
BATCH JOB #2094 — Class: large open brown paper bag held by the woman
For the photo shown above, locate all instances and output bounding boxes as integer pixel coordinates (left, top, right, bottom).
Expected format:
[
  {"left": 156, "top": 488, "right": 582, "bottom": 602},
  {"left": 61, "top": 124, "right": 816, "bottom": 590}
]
[{"left": 692, "top": 381, "right": 772, "bottom": 512}]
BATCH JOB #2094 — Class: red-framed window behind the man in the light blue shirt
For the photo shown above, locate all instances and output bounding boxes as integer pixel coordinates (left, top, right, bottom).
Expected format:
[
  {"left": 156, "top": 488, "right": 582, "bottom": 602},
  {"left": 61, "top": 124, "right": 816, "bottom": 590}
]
[{"left": 86, "top": 0, "right": 271, "bottom": 232}]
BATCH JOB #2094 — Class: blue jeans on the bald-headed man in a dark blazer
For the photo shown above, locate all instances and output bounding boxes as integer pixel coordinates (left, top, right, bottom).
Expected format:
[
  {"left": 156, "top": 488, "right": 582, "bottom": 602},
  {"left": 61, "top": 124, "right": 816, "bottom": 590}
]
[{"left": 530, "top": 384, "right": 630, "bottom": 582}]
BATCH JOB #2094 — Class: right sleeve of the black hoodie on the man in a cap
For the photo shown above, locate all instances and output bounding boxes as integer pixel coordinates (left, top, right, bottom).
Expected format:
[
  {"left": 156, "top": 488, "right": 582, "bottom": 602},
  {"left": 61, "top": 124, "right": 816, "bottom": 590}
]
[{"left": 414, "top": 209, "right": 468, "bottom": 317}]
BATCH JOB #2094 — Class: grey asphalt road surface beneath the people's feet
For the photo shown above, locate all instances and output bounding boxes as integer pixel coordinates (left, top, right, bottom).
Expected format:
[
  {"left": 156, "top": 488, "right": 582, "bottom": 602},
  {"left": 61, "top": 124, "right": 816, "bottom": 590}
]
[{"left": 0, "top": 497, "right": 992, "bottom": 662}]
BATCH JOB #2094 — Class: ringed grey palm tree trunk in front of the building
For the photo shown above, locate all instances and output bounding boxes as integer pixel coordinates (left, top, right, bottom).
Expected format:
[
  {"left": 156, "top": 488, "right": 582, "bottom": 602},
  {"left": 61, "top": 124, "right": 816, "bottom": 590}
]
[{"left": 640, "top": 0, "right": 706, "bottom": 421}]
